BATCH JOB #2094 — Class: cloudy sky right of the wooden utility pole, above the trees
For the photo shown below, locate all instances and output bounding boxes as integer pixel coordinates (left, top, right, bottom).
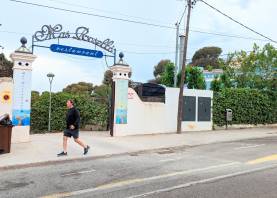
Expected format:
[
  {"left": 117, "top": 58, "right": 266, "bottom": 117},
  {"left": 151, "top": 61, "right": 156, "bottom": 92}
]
[{"left": 189, "top": 0, "right": 277, "bottom": 55}]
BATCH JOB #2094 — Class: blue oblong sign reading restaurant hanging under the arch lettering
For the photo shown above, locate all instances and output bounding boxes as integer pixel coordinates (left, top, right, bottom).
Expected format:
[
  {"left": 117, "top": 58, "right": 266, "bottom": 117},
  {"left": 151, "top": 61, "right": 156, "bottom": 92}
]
[{"left": 50, "top": 44, "right": 103, "bottom": 58}]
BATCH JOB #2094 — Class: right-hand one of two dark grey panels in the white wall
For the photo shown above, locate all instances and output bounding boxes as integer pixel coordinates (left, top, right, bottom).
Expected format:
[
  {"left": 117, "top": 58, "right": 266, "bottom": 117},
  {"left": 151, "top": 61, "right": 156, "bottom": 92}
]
[{"left": 198, "top": 97, "right": 211, "bottom": 121}]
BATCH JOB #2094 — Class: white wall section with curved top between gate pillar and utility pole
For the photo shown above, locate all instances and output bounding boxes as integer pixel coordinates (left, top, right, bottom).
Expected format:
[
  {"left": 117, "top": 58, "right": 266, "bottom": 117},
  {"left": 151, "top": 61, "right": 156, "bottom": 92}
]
[{"left": 114, "top": 88, "right": 178, "bottom": 136}]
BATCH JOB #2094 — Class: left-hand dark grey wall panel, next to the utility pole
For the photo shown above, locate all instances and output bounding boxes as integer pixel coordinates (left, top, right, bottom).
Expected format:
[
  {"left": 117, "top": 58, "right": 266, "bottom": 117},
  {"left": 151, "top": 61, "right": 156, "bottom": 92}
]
[{"left": 183, "top": 96, "right": 196, "bottom": 121}]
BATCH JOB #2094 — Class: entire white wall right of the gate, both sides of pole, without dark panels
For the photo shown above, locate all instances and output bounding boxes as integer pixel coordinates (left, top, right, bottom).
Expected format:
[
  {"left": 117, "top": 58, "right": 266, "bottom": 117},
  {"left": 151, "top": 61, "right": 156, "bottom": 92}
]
[{"left": 114, "top": 88, "right": 213, "bottom": 136}]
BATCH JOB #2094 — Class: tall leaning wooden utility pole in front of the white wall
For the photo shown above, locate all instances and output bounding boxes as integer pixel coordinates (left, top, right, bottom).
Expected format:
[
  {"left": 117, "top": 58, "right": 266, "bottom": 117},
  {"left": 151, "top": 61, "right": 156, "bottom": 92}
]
[{"left": 177, "top": 0, "right": 195, "bottom": 133}]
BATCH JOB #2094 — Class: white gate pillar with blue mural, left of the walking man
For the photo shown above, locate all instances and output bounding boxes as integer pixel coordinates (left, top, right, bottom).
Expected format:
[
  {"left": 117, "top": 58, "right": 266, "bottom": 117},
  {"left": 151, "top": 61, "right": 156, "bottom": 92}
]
[{"left": 10, "top": 37, "right": 36, "bottom": 143}]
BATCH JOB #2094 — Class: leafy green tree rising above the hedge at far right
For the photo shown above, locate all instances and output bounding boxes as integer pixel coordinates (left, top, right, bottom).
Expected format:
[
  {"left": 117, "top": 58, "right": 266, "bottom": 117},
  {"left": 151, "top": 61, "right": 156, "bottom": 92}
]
[{"left": 224, "top": 44, "right": 277, "bottom": 90}]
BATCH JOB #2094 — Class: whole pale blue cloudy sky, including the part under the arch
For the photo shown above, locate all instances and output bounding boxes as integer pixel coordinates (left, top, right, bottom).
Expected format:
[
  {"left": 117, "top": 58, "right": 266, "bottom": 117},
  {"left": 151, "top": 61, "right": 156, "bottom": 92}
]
[{"left": 0, "top": 0, "right": 277, "bottom": 91}]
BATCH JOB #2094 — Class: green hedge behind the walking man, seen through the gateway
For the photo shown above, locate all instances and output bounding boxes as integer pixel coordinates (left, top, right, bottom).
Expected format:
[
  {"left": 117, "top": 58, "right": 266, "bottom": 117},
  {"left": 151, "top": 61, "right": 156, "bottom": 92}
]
[{"left": 31, "top": 92, "right": 108, "bottom": 133}]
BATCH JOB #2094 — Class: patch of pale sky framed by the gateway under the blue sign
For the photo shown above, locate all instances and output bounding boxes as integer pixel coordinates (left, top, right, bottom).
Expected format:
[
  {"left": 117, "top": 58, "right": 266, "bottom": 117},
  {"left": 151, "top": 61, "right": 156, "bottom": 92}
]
[{"left": 32, "top": 55, "right": 103, "bottom": 92}]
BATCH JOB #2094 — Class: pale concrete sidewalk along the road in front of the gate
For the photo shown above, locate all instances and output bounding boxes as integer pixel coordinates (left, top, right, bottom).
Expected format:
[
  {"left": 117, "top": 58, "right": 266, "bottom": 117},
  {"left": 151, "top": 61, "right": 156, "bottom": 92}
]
[{"left": 0, "top": 128, "right": 277, "bottom": 169}]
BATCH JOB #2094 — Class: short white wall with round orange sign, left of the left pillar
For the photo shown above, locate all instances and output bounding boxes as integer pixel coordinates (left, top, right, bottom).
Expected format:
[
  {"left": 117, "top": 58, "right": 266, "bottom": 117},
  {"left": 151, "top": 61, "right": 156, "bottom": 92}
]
[{"left": 0, "top": 77, "right": 13, "bottom": 116}]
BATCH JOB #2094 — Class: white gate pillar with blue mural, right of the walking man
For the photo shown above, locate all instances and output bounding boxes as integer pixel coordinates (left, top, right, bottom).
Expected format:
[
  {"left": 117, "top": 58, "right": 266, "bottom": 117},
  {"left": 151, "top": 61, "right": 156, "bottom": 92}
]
[{"left": 110, "top": 53, "right": 131, "bottom": 136}]
